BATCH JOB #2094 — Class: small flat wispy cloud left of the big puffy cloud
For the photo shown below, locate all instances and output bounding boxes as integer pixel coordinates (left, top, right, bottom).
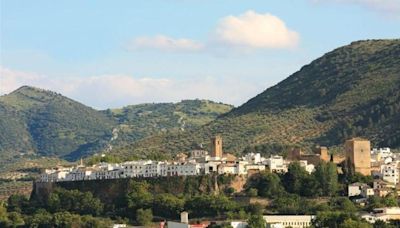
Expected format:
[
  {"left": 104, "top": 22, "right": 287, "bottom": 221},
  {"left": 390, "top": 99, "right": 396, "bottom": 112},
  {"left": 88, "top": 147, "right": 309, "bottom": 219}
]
[{"left": 127, "top": 35, "right": 203, "bottom": 51}]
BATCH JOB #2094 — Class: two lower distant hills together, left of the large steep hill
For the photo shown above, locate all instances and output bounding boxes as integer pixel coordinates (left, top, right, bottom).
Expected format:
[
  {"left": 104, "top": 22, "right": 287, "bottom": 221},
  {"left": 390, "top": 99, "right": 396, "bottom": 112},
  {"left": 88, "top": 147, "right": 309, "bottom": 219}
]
[{"left": 0, "top": 86, "right": 233, "bottom": 163}]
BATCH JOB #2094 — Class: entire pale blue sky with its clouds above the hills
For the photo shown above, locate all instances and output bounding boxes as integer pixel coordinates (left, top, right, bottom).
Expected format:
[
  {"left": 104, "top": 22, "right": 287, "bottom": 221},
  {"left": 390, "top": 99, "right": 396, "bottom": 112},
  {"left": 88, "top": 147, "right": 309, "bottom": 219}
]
[{"left": 0, "top": 0, "right": 400, "bottom": 109}]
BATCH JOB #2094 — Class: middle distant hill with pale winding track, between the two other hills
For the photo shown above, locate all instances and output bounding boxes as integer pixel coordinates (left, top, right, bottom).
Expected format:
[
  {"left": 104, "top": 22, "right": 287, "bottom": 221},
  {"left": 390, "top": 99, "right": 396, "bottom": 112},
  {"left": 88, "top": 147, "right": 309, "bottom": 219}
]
[{"left": 104, "top": 100, "right": 233, "bottom": 149}]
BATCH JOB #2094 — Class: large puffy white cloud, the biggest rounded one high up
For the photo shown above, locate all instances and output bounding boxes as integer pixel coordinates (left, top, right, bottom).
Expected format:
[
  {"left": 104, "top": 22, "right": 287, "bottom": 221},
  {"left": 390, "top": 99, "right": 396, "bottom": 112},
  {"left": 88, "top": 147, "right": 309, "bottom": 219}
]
[{"left": 214, "top": 10, "right": 299, "bottom": 48}]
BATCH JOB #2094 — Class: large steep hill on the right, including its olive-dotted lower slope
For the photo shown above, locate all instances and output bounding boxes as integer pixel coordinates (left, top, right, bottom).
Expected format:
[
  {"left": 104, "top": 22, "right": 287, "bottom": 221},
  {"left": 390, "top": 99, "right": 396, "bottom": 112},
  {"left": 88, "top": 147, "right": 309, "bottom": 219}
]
[{"left": 113, "top": 39, "right": 400, "bottom": 159}]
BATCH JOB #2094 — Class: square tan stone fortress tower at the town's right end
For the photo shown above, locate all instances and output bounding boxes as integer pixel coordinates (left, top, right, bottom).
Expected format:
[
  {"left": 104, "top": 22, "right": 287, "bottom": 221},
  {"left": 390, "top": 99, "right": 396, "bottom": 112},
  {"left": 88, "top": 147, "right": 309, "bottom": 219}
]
[{"left": 344, "top": 138, "right": 371, "bottom": 175}]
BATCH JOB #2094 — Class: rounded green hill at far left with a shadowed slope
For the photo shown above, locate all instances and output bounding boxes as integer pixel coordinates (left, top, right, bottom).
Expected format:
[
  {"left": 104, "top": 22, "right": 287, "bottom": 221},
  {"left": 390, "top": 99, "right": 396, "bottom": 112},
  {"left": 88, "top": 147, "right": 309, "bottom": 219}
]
[{"left": 0, "top": 86, "right": 115, "bottom": 162}]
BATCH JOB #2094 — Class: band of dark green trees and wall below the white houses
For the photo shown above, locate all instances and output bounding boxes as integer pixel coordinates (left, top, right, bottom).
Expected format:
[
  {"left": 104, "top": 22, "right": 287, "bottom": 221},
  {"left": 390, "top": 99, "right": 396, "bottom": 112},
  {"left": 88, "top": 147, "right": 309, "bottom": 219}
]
[{"left": 0, "top": 162, "right": 398, "bottom": 228}]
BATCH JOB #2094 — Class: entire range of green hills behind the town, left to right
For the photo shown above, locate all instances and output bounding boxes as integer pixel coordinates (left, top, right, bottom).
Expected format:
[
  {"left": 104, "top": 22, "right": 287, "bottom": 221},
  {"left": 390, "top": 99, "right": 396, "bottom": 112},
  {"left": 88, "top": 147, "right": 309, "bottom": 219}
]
[{"left": 0, "top": 39, "right": 400, "bottom": 166}]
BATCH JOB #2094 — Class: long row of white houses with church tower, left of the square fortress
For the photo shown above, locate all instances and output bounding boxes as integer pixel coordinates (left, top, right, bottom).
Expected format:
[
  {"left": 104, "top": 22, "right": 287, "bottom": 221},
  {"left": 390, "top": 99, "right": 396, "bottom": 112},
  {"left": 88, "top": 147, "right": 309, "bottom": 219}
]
[{"left": 39, "top": 136, "right": 316, "bottom": 182}]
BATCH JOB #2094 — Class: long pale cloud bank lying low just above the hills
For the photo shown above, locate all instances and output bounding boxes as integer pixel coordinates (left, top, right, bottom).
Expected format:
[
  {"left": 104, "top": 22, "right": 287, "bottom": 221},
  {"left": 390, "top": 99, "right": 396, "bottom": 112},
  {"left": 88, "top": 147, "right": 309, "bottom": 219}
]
[{"left": 0, "top": 67, "right": 265, "bottom": 109}]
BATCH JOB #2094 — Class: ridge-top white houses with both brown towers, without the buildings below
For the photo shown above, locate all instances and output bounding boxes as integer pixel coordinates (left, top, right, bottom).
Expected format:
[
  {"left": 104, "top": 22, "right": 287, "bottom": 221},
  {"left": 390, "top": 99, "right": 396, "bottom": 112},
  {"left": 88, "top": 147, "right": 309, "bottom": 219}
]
[{"left": 38, "top": 136, "right": 400, "bottom": 186}]
